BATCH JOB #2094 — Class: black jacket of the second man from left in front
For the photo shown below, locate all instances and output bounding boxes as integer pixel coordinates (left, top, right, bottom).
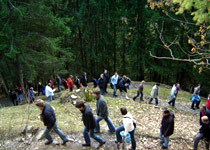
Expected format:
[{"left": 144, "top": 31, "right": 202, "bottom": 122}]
[{"left": 81, "top": 105, "right": 96, "bottom": 131}]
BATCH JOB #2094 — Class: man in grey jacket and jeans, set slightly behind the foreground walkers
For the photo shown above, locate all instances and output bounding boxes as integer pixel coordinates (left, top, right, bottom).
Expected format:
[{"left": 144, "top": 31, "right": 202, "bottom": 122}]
[{"left": 93, "top": 90, "right": 115, "bottom": 133}]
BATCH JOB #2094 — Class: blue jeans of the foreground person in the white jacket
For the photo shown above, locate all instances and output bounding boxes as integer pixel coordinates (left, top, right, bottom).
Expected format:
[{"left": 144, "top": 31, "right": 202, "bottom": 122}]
[{"left": 115, "top": 126, "right": 136, "bottom": 150}]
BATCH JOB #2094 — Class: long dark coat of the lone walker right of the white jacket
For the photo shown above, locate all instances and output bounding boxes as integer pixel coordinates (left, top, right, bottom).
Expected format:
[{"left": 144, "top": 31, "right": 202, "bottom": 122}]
[{"left": 160, "top": 113, "right": 175, "bottom": 137}]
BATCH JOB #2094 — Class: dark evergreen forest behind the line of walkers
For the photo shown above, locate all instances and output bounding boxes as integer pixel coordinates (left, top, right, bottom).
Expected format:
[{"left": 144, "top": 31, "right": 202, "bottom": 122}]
[{"left": 0, "top": 0, "right": 210, "bottom": 96}]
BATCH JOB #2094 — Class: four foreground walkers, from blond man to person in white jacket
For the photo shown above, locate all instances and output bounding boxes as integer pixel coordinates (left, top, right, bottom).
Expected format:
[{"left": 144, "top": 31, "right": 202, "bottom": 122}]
[{"left": 34, "top": 90, "right": 136, "bottom": 150}]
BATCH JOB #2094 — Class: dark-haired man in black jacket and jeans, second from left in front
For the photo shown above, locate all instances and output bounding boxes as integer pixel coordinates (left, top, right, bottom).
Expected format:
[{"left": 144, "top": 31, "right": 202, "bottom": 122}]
[{"left": 75, "top": 101, "right": 106, "bottom": 149}]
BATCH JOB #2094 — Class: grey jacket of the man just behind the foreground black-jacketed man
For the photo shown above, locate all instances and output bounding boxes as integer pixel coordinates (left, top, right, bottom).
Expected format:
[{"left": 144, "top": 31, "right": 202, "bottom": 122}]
[{"left": 96, "top": 96, "right": 109, "bottom": 118}]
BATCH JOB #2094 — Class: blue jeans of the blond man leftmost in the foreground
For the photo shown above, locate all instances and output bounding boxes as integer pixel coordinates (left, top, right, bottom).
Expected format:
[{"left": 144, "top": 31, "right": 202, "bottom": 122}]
[{"left": 44, "top": 122, "right": 68, "bottom": 142}]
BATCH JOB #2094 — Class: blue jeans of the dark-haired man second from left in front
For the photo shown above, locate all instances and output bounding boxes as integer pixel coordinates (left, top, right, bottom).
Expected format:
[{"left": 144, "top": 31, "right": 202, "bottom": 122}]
[{"left": 83, "top": 127, "right": 104, "bottom": 144}]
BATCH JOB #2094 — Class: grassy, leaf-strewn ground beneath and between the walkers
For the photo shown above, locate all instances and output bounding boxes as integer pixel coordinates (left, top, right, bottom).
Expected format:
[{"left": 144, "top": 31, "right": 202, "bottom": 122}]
[{"left": 0, "top": 83, "right": 205, "bottom": 150}]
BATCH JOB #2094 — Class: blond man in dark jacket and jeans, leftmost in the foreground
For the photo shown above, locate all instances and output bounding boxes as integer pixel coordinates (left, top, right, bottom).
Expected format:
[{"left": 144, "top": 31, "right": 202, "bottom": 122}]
[{"left": 35, "top": 99, "right": 70, "bottom": 145}]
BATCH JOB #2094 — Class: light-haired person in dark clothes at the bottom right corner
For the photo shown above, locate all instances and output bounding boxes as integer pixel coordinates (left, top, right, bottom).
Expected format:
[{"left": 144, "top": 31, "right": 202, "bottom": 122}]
[{"left": 193, "top": 116, "right": 210, "bottom": 150}]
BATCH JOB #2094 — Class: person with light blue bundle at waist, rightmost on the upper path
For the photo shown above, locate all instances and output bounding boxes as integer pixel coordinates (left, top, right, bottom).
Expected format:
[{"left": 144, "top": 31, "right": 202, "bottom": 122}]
[{"left": 191, "top": 84, "right": 201, "bottom": 110}]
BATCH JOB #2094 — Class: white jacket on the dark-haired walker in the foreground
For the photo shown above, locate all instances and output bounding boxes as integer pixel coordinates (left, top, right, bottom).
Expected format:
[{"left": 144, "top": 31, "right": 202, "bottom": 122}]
[{"left": 123, "top": 112, "right": 134, "bottom": 136}]
